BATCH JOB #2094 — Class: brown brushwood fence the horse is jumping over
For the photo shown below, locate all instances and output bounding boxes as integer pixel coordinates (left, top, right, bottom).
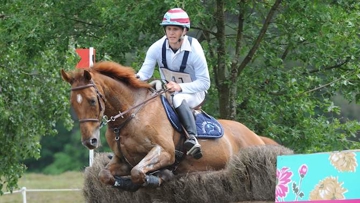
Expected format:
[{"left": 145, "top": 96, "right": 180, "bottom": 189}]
[{"left": 83, "top": 145, "right": 293, "bottom": 203}]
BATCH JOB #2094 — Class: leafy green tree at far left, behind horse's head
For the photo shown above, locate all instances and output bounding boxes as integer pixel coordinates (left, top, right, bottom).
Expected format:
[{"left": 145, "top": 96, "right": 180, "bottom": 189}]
[{"left": 0, "top": 1, "right": 75, "bottom": 193}]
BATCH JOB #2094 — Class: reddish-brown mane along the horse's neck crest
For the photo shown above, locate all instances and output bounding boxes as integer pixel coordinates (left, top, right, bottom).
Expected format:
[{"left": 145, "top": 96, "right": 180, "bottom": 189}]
[{"left": 89, "top": 61, "right": 151, "bottom": 88}]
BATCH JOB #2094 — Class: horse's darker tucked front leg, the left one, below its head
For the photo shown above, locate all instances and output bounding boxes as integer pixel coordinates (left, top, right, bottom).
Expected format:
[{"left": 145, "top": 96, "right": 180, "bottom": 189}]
[{"left": 99, "top": 155, "right": 131, "bottom": 186}]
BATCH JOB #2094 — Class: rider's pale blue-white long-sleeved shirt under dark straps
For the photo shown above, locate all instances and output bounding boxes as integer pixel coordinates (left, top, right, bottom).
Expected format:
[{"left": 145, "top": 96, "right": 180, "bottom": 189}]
[{"left": 137, "top": 36, "right": 210, "bottom": 93}]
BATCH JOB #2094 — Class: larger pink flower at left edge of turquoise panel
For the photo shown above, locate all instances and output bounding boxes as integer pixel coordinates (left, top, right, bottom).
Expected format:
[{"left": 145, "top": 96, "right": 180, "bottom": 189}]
[{"left": 275, "top": 167, "right": 293, "bottom": 202}]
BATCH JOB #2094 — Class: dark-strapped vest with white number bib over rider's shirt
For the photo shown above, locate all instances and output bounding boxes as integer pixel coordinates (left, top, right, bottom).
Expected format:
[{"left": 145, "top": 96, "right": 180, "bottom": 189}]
[{"left": 160, "top": 36, "right": 192, "bottom": 83}]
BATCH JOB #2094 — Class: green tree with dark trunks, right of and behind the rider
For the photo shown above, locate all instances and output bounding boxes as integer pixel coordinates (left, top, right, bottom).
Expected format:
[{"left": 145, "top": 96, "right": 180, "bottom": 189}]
[{"left": 175, "top": 0, "right": 360, "bottom": 152}]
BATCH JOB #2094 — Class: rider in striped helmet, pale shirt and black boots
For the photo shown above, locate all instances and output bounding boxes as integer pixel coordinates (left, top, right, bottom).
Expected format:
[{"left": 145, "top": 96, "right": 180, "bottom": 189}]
[{"left": 137, "top": 8, "right": 210, "bottom": 159}]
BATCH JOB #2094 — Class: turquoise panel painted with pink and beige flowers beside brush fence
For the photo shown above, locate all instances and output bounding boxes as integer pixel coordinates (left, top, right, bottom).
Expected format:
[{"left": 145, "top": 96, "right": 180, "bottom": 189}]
[{"left": 275, "top": 149, "right": 360, "bottom": 203}]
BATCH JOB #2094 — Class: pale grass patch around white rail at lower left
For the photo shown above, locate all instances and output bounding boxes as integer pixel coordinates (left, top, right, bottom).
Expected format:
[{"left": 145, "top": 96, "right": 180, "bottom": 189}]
[{"left": 0, "top": 172, "right": 85, "bottom": 203}]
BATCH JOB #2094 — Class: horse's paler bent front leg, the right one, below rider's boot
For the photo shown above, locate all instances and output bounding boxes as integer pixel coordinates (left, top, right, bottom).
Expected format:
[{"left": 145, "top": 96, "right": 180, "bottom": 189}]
[{"left": 131, "top": 145, "right": 175, "bottom": 186}]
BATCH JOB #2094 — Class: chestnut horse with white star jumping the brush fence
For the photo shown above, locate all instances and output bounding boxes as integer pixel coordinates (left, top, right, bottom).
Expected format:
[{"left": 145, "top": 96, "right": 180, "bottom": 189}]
[{"left": 61, "top": 62, "right": 276, "bottom": 191}]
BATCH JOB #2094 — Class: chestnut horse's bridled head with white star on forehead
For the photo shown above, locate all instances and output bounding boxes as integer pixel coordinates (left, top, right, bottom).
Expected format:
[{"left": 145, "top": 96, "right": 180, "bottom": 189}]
[{"left": 61, "top": 69, "right": 105, "bottom": 149}]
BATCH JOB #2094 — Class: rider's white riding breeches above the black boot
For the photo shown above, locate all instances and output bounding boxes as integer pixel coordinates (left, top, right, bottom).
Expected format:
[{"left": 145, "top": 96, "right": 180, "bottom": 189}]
[{"left": 173, "top": 92, "right": 206, "bottom": 108}]
